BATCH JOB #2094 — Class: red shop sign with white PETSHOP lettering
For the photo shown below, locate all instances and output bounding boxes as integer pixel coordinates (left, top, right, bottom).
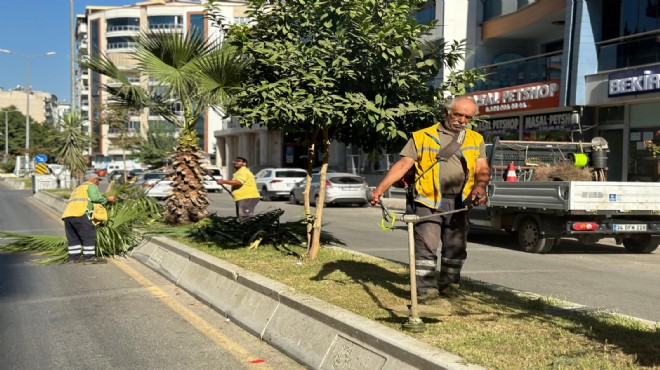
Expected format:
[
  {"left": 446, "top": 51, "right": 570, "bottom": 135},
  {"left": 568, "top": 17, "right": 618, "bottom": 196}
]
[{"left": 467, "top": 81, "right": 559, "bottom": 114}]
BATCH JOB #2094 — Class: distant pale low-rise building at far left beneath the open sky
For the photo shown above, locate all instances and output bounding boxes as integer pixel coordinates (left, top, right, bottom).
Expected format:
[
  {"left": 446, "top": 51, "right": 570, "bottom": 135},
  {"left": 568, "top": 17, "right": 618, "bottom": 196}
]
[{"left": 0, "top": 86, "right": 58, "bottom": 124}]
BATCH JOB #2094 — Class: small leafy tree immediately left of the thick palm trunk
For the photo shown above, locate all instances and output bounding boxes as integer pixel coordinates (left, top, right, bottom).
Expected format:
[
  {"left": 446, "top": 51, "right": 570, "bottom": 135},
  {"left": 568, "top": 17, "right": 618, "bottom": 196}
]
[{"left": 137, "top": 122, "right": 176, "bottom": 167}]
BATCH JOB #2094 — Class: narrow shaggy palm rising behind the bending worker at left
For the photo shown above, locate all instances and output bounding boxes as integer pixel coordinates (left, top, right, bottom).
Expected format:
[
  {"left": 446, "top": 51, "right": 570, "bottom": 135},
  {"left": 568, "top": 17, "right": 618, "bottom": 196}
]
[{"left": 55, "top": 112, "right": 90, "bottom": 185}]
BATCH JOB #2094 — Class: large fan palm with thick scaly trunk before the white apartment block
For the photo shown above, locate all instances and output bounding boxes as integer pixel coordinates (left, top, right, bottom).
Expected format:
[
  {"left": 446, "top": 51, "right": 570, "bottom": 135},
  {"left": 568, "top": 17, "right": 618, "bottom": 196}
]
[{"left": 80, "top": 30, "right": 245, "bottom": 225}]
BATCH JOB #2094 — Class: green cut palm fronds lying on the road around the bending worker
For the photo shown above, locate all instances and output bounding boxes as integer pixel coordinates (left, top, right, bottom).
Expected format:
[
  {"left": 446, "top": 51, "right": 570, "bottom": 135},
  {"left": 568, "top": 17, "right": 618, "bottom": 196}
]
[{"left": 0, "top": 186, "right": 160, "bottom": 264}]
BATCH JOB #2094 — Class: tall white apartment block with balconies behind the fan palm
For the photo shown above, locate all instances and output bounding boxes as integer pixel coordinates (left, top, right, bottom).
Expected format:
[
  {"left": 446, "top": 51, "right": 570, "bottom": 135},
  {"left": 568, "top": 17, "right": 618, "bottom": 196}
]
[{"left": 76, "top": 0, "right": 244, "bottom": 167}]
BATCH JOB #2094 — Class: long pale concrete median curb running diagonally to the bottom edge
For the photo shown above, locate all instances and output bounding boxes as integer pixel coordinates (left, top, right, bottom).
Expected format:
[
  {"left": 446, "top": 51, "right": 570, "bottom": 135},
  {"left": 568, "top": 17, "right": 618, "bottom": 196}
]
[{"left": 131, "top": 237, "right": 481, "bottom": 370}]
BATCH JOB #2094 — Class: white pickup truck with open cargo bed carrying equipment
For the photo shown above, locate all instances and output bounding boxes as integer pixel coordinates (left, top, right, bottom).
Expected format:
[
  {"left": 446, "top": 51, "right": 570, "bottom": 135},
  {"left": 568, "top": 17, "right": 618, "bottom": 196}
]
[{"left": 470, "top": 138, "right": 660, "bottom": 253}]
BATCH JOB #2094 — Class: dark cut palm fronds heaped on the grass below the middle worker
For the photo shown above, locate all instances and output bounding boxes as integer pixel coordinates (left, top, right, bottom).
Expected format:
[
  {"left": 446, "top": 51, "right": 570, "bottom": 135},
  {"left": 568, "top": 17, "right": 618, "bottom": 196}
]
[{"left": 148, "top": 209, "right": 345, "bottom": 249}]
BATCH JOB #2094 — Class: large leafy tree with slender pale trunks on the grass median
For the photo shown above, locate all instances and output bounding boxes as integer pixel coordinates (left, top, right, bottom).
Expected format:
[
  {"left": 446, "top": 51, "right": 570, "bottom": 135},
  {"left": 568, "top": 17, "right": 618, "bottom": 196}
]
[{"left": 224, "top": 0, "right": 482, "bottom": 259}]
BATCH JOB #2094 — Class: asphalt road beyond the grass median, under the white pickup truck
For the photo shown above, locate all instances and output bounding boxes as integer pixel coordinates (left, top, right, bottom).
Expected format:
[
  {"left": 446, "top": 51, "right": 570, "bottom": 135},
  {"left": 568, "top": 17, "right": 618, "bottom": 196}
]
[{"left": 210, "top": 189, "right": 660, "bottom": 322}]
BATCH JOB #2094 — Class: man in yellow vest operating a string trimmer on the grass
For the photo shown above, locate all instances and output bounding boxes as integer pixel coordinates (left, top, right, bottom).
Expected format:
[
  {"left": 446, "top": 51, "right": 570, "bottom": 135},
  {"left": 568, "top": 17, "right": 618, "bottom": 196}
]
[{"left": 372, "top": 97, "right": 490, "bottom": 302}]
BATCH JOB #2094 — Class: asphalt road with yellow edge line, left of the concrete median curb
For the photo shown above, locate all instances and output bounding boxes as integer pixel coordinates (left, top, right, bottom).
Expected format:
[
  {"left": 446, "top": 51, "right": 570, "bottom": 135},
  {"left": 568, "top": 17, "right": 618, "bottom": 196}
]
[{"left": 0, "top": 185, "right": 302, "bottom": 369}]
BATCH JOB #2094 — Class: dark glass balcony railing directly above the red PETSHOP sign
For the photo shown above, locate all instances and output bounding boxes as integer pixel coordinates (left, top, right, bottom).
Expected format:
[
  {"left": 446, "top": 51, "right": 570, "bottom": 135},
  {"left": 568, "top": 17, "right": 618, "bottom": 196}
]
[{"left": 470, "top": 51, "right": 563, "bottom": 92}]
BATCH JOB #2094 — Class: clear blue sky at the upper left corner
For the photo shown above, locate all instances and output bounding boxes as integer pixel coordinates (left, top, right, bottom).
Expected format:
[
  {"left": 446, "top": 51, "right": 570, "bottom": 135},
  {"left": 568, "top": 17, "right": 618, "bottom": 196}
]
[{"left": 0, "top": 0, "right": 138, "bottom": 102}]
